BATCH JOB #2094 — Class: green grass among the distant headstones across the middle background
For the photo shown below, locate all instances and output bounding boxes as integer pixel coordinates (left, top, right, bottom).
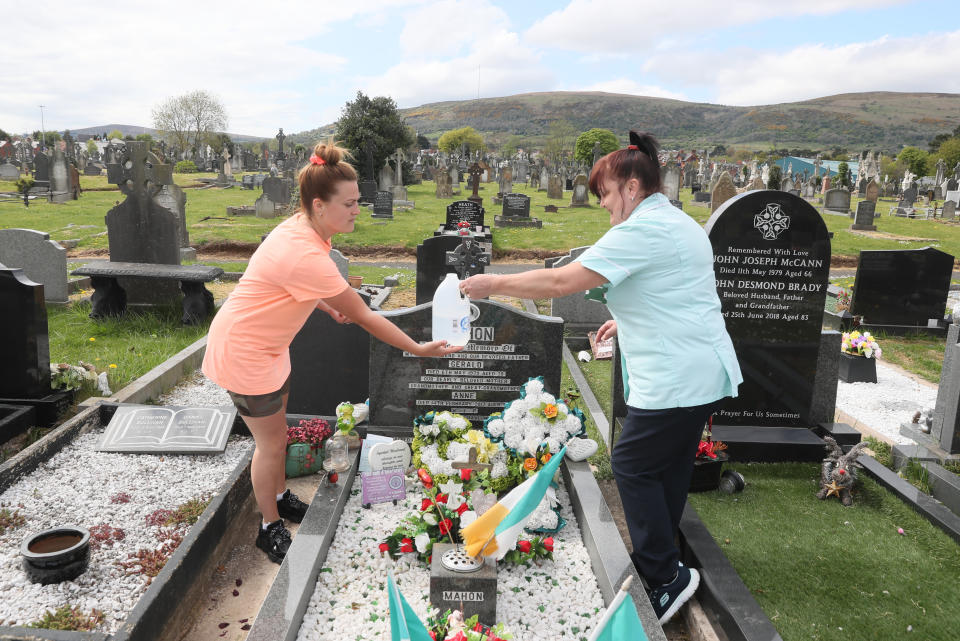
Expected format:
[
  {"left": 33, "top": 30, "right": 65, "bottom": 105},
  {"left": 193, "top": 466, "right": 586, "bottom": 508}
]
[{"left": 7, "top": 173, "right": 960, "bottom": 256}]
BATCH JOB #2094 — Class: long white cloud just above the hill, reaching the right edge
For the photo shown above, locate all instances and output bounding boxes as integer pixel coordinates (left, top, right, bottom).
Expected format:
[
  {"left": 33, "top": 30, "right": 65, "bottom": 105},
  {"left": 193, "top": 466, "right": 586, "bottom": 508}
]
[{"left": 644, "top": 31, "right": 960, "bottom": 105}]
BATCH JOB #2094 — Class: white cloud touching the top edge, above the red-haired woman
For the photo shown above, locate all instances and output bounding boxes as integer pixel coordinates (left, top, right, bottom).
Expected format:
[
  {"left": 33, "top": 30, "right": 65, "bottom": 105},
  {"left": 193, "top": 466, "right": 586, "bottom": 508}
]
[{"left": 524, "top": 0, "right": 906, "bottom": 54}]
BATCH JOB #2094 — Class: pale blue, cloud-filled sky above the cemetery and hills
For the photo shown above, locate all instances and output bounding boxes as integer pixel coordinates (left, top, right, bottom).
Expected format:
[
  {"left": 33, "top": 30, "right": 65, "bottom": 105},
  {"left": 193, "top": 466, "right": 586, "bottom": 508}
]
[{"left": 0, "top": 0, "right": 960, "bottom": 136}]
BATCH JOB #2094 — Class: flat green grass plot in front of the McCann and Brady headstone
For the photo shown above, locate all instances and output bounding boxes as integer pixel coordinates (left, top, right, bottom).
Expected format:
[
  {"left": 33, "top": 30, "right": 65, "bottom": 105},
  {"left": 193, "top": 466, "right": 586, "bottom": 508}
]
[{"left": 689, "top": 463, "right": 960, "bottom": 641}]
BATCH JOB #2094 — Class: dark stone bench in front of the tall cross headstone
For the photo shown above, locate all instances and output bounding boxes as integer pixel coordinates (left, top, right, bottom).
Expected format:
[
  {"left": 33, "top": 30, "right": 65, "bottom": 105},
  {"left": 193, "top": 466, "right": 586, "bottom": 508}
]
[{"left": 70, "top": 262, "right": 223, "bottom": 325}]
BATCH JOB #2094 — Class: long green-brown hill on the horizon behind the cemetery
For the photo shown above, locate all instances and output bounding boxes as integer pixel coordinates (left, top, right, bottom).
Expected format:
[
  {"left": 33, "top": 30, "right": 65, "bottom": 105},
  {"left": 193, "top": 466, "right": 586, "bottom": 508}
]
[{"left": 290, "top": 91, "right": 960, "bottom": 153}]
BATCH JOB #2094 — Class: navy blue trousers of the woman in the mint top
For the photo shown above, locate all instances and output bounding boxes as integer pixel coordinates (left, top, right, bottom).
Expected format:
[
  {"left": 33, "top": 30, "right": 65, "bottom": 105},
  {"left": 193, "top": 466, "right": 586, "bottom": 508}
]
[{"left": 611, "top": 401, "right": 719, "bottom": 588}]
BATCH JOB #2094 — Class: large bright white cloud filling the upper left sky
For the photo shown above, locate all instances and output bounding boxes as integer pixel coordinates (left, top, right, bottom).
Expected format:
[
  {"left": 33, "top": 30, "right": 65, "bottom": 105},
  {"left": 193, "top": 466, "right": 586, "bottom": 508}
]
[{"left": 0, "top": 0, "right": 411, "bottom": 136}]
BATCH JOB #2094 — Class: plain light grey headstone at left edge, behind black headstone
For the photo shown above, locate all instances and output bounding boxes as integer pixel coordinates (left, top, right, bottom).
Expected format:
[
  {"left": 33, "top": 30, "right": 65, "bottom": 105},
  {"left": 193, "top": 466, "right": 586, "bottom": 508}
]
[{"left": 0, "top": 229, "right": 68, "bottom": 303}]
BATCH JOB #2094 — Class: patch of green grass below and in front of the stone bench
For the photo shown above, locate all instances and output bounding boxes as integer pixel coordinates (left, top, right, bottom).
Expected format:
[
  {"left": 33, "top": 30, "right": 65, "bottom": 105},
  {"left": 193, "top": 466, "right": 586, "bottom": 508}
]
[{"left": 47, "top": 301, "right": 210, "bottom": 403}]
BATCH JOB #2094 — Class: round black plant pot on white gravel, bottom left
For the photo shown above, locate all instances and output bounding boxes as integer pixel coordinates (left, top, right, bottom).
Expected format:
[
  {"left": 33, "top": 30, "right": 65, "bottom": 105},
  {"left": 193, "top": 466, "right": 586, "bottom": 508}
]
[{"left": 20, "top": 525, "right": 90, "bottom": 584}]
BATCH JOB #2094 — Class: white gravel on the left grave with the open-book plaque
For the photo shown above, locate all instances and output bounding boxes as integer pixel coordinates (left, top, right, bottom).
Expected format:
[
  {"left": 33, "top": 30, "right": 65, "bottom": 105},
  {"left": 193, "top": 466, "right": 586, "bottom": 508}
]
[{"left": 0, "top": 370, "right": 253, "bottom": 633}]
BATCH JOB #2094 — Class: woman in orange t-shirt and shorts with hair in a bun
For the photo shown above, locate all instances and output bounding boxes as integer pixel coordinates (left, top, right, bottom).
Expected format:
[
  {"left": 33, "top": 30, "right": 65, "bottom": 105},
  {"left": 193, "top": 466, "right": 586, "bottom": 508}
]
[{"left": 202, "top": 144, "right": 462, "bottom": 563}]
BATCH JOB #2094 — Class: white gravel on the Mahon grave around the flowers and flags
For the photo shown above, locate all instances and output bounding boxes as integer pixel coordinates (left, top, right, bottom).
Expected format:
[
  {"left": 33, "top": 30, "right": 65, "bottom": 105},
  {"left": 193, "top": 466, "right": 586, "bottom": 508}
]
[{"left": 297, "top": 478, "right": 604, "bottom": 641}]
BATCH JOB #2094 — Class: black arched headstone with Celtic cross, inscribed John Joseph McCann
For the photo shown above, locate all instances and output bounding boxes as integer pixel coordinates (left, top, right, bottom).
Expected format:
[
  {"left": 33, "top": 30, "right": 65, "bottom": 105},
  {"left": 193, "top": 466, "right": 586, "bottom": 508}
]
[{"left": 704, "top": 190, "right": 830, "bottom": 426}]
